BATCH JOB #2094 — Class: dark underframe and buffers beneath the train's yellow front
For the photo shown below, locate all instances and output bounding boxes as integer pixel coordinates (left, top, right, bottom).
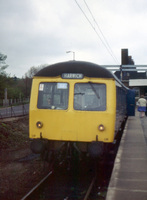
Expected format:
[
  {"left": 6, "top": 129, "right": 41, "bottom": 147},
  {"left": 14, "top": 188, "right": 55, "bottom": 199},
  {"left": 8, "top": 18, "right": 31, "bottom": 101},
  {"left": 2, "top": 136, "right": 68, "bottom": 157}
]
[{"left": 31, "top": 139, "right": 114, "bottom": 162}]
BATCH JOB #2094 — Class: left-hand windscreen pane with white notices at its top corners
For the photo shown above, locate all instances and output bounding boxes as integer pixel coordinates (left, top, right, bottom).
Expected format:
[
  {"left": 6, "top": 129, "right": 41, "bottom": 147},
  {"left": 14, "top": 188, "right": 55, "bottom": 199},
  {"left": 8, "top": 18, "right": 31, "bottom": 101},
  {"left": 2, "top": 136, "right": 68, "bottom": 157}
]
[{"left": 37, "top": 83, "right": 69, "bottom": 110}]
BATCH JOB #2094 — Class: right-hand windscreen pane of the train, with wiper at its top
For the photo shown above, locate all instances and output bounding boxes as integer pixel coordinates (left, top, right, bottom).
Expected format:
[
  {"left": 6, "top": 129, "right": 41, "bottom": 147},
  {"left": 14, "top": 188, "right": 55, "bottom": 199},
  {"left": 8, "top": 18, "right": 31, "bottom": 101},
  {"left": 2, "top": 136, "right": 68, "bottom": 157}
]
[{"left": 74, "top": 82, "right": 106, "bottom": 111}]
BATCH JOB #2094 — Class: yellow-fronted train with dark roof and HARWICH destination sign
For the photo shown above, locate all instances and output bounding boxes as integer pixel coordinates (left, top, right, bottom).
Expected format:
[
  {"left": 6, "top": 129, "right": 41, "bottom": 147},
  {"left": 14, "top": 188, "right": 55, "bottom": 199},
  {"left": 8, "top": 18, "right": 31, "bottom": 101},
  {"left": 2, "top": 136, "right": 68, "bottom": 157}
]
[{"left": 29, "top": 61, "right": 127, "bottom": 157}]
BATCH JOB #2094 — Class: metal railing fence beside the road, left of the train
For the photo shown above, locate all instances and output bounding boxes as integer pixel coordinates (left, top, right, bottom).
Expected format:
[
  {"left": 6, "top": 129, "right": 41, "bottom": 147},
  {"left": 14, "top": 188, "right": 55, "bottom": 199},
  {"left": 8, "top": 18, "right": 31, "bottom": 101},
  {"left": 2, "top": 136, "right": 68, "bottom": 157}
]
[{"left": 0, "top": 104, "right": 29, "bottom": 119}]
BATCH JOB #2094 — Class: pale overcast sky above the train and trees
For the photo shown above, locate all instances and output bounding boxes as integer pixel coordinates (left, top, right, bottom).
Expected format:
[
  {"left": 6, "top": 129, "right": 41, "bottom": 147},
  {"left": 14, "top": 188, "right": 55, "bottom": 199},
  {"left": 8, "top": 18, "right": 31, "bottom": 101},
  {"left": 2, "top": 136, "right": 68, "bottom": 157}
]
[{"left": 0, "top": 0, "right": 147, "bottom": 78}]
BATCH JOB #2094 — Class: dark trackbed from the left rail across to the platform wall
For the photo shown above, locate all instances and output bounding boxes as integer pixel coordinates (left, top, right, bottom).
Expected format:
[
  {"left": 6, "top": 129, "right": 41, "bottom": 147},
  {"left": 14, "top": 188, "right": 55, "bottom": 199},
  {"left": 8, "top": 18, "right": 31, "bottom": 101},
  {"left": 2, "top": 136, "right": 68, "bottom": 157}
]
[{"left": 21, "top": 123, "right": 124, "bottom": 200}]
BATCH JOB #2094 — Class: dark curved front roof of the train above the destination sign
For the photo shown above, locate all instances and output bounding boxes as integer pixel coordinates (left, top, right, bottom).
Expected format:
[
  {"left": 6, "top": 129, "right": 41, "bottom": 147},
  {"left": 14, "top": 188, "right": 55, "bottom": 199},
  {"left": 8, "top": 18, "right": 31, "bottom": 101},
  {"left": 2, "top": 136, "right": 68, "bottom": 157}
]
[{"left": 35, "top": 61, "right": 116, "bottom": 79}]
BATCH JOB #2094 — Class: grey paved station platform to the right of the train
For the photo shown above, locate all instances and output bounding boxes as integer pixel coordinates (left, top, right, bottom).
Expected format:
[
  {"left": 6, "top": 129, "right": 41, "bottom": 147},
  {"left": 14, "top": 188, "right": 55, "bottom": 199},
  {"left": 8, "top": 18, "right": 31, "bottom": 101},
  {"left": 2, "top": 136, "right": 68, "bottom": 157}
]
[{"left": 106, "top": 111, "right": 147, "bottom": 200}]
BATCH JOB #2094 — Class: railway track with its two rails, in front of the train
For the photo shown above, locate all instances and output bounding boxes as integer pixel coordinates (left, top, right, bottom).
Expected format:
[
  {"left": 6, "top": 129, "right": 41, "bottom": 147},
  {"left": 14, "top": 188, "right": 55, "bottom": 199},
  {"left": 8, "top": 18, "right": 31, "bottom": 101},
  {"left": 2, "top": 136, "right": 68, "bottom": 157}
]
[{"left": 21, "top": 155, "right": 111, "bottom": 200}]
